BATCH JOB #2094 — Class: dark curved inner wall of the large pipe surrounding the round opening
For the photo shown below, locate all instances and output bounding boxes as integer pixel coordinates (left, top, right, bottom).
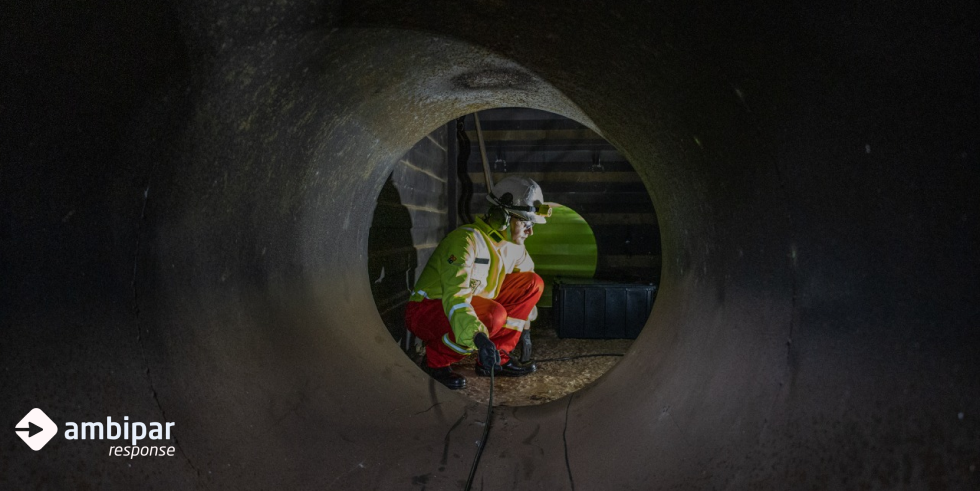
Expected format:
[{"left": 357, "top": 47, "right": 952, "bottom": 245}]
[{"left": 0, "top": 1, "right": 980, "bottom": 489}]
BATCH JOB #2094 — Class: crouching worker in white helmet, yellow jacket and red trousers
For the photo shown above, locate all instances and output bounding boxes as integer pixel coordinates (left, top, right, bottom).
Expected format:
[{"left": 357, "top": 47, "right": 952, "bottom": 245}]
[{"left": 405, "top": 177, "right": 551, "bottom": 390}]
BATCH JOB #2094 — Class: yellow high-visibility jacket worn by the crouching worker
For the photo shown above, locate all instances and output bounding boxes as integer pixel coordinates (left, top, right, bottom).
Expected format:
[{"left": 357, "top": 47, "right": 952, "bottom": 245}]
[{"left": 410, "top": 218, "right": 534, "bottom": 351}]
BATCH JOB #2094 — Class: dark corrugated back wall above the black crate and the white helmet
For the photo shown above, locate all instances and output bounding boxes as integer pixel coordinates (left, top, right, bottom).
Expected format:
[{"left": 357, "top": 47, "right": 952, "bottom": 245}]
[{"left": 466, "top": 108, "right": 661, "bottom": 282}]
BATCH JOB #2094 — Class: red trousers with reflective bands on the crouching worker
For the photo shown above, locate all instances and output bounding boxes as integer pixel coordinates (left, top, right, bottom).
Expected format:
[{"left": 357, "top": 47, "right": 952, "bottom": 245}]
[{"left": 405, "top": 273, "right": 544, "bottom": 368}]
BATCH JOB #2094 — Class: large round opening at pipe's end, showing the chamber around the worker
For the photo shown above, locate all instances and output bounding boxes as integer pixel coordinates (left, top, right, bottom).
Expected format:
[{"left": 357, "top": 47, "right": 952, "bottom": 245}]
[{"left": 367, "top": 108, "right": 660, "bottom": 406}]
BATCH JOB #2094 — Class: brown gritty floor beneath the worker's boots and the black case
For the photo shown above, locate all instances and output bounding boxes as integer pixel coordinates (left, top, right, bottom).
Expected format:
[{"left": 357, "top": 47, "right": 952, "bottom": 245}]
[{"left": 453, "top": 324, "right": 633, "bottom": 406}]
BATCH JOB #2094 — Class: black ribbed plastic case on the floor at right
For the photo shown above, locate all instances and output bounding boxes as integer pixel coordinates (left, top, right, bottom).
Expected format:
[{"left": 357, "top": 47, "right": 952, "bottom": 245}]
[{"left": 552, "top": 278, "right": 657, "bottom": 339}]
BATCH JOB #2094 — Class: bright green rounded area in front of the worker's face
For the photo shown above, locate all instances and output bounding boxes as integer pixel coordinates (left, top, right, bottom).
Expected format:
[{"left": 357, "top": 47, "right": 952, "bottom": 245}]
[{"left": 524, "top": 204, "right": 598, "bottom": 307}]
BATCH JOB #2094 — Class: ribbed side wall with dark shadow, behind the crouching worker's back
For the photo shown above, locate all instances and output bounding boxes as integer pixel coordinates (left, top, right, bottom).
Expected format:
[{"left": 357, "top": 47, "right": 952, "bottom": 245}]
[{"left": 368, "top": 127, "right": 455, "bottom": 339}]
